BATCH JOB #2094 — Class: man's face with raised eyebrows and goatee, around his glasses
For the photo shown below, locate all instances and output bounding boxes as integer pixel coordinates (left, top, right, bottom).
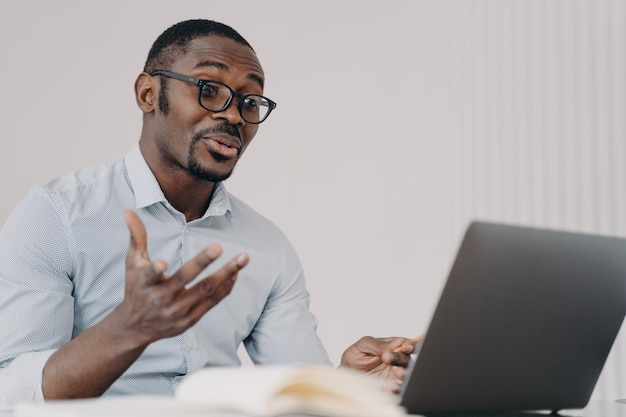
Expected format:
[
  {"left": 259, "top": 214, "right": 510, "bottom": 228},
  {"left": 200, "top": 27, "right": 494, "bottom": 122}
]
[{"left": 155, "top": 36, "right": 264, "bottom": 182}]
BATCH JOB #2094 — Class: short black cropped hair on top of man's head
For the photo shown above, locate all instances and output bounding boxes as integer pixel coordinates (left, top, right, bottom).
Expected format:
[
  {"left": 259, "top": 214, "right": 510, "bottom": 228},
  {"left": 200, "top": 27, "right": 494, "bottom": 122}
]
[{"left": 143, "top": 19, "right": 254, "bottom": 73}]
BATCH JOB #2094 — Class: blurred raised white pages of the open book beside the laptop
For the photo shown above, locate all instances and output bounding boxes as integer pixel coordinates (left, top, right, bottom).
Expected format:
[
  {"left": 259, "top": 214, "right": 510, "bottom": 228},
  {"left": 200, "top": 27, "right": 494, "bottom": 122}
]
[{"left": 176, "top": 366, "right": 404, "bottom": 417}]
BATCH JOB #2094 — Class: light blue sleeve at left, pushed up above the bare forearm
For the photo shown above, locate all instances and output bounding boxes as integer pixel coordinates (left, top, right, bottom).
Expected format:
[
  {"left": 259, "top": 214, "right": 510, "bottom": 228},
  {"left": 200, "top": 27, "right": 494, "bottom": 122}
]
[{"left": 0, "top": 189, "right": 74, "bottom": 406}]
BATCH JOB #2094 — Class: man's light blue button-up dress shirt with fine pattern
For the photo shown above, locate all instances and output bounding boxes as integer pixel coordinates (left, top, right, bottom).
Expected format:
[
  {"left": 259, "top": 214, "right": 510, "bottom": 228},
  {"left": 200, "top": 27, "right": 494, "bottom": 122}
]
[{"left": 0, "top": 145, "right": 330, "bottom": 405}]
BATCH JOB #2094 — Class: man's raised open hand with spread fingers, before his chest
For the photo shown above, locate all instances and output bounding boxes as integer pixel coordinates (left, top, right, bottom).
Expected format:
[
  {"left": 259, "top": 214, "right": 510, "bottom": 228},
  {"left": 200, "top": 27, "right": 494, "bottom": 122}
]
[{"left": 118, "top": 210, "right": 248, "bottom": 343}]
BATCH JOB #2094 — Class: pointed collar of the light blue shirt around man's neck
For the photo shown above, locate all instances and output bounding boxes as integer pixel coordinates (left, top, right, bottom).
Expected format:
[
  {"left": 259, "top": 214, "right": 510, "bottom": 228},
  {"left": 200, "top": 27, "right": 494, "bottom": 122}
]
[{"left": 124, "top": 143, "right": 232, "bottom": 219}]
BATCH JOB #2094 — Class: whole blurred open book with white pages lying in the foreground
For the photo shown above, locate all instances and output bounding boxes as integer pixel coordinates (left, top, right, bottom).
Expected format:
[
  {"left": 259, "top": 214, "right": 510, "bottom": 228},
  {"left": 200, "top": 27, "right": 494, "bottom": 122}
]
[{"left": 15, "top": 366, "right": 405, "bottom": 417}]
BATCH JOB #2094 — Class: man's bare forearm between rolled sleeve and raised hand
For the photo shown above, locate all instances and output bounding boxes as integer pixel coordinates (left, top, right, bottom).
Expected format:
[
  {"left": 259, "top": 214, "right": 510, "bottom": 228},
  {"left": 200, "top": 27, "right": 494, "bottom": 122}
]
[{"left": 42, "top": 310, "right": 149, "bottom": 400}]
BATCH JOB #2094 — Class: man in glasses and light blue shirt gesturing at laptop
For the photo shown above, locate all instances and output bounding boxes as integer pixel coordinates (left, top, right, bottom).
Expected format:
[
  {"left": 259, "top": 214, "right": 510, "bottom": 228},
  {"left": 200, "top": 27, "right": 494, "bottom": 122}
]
[{"left": 0, "top": 20, "right": 413, "bottom": 404}]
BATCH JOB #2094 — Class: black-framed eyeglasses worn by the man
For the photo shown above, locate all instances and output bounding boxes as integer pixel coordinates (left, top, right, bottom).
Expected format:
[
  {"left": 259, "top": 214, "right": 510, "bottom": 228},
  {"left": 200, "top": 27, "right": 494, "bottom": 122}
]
[{"left": 150, "top": 70, "right": 276, "bottom": 124}]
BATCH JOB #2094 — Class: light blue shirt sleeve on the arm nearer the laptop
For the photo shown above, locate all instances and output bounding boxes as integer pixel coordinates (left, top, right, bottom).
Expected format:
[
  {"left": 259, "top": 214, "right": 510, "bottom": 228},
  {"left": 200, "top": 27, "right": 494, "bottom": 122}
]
[{"left": 244, "top": 232, "right": 331, "bottom": 365}]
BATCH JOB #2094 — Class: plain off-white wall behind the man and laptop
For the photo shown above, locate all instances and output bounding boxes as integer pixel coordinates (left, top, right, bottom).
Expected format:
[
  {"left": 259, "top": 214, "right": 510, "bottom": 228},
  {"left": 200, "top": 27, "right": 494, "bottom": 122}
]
[{"left": 0, "top": 0, "right": 626, "bottom": 398}]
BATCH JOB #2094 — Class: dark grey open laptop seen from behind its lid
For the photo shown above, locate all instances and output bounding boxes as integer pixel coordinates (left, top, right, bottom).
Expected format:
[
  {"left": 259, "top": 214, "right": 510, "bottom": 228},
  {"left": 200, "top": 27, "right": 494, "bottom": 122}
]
[{"left": 400, "top": 222, "right": 626, "bottom": 415}]
